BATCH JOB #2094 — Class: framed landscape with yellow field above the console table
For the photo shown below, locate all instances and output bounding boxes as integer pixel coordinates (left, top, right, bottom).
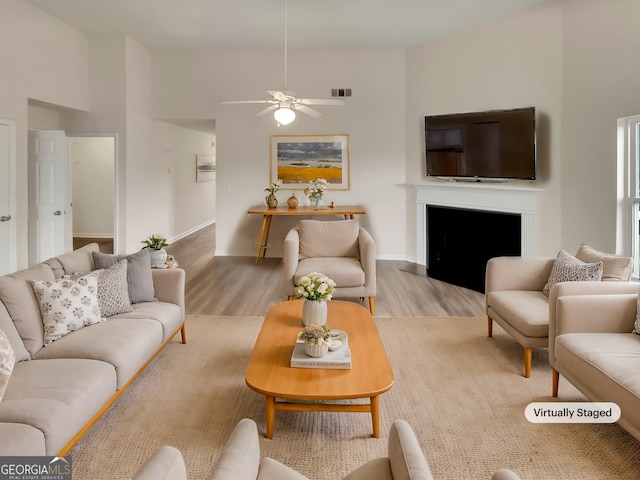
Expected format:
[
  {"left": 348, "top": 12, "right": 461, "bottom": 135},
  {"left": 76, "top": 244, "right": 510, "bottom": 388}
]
[{"left": 270, "top": 134, "right": 349, "bottom": 190}]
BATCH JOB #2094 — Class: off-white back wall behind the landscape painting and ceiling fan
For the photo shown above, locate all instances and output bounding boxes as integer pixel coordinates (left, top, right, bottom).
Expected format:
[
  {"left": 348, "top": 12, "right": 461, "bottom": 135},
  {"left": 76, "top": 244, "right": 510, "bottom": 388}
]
[{"left": 153, "top": 50, "right": 406, "bottom": 258}]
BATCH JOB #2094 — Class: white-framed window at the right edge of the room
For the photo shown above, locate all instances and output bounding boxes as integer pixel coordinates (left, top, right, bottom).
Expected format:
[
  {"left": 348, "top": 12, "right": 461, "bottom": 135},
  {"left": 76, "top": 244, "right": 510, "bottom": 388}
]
[{"left": 616, "top": 115, "right": 640, "bottom": 278}]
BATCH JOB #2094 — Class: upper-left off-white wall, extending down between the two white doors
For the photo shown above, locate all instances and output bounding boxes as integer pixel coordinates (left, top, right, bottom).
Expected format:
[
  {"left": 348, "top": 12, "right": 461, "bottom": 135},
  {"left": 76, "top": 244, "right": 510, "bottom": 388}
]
[{"left": 0, "top": 0, "right": 89, "bottom": 268}]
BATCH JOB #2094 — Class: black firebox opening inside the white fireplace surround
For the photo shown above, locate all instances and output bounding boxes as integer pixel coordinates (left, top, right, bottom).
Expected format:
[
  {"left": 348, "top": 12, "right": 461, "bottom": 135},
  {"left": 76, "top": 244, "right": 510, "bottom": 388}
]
[{"left": 427, "top": 206, "right": 521, "bottom": 293}]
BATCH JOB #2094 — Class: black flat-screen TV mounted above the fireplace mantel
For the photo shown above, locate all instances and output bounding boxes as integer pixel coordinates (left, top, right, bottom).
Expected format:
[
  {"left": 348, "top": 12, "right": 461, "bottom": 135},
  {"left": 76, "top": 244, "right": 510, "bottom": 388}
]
[{"left": 425, "top": 107, "right": 536, "bottom": 181}]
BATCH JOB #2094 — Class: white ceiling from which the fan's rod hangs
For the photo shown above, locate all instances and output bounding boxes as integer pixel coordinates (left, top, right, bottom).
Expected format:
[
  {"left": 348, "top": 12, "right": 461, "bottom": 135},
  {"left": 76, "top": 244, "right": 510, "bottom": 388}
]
[{"left": 26, "top": 0, "right": 557, "bottom": 50}]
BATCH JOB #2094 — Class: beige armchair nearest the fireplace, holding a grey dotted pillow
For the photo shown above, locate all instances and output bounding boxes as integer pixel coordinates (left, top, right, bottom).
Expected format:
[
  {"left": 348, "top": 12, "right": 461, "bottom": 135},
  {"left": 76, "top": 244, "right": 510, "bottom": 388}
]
[{"left": 485, "top": 245, "right": 638, "bottom": 378}]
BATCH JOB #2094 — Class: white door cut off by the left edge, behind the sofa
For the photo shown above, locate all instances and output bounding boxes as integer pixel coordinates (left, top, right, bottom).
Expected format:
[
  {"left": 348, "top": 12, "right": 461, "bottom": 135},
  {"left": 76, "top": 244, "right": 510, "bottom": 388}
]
[{"left": 0, "top": 119, "right": 17, "bottom": 275}]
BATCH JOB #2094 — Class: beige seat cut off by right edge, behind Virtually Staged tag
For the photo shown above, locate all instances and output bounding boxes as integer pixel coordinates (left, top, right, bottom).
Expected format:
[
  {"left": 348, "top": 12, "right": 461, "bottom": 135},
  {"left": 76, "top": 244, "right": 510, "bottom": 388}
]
[{"left": 549, "top": 294, "right": 640, "bottom": 440}]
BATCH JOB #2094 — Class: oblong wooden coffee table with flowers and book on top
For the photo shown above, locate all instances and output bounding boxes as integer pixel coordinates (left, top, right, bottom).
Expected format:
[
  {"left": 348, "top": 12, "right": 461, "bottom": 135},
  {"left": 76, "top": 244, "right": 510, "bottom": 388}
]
[{"left": 245, "top": 300, "right": 394, "bottom": 438}]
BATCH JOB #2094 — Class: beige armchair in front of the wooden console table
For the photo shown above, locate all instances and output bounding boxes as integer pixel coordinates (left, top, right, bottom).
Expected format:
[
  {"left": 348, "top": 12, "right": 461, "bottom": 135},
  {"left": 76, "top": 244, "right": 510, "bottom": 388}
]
[{"left": 284, "top": 220, "right": 376, "bottom": 315}]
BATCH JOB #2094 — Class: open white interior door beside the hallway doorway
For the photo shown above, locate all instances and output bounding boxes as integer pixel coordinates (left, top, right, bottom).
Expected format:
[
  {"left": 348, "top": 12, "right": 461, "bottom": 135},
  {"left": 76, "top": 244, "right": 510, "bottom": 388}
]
[{"left": 29, "top": 130, "right": 73, "bottom": 265}]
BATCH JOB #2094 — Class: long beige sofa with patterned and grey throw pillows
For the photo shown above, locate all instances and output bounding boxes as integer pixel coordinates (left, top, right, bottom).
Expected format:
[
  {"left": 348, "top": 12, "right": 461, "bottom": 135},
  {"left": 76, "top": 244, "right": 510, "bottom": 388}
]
[{"left": 0, "top": 244, "right": 186, "bottom": 456}]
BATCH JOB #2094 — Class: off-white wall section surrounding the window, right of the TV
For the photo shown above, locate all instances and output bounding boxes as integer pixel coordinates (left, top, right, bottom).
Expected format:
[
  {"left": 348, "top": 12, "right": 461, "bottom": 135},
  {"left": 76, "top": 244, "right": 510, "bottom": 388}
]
[{"left": 562, "top": 0, "right": 640, "bottom": 255}]
